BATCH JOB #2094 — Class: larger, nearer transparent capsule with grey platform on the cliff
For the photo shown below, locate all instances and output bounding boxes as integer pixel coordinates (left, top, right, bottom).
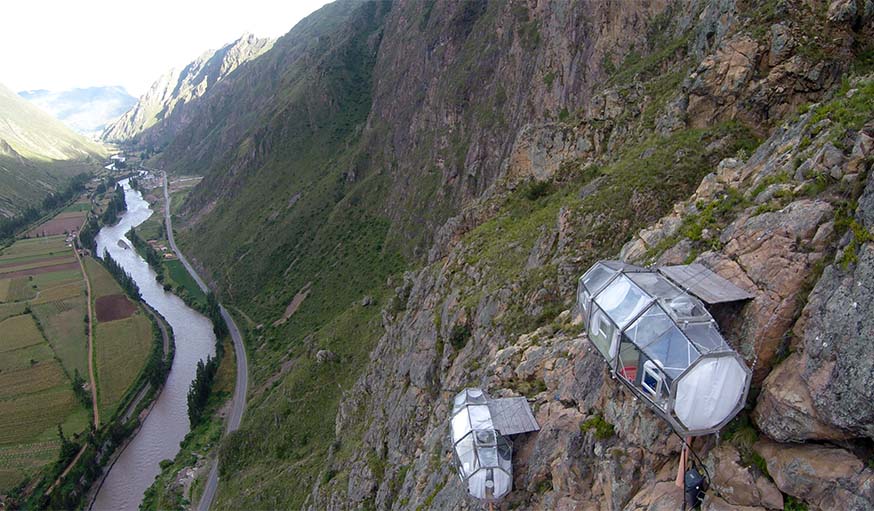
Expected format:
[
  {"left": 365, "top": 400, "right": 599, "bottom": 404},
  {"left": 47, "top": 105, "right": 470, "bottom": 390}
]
[{"left": 577, "top": 261, "right": 752, "bottom": 436}]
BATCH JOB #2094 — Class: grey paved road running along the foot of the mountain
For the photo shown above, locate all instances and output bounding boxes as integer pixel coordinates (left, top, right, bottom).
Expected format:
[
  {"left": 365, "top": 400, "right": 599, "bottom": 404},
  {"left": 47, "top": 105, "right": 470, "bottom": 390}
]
[{"left": 163, "top": 172, "right": 249, "bottom": 511}]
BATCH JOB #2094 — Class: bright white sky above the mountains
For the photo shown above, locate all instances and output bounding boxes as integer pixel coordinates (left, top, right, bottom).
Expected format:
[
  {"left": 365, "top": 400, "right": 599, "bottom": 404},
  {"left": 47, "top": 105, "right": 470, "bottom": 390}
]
[{"left": 0, "top": 0, "right": 328, "bottom": 96}]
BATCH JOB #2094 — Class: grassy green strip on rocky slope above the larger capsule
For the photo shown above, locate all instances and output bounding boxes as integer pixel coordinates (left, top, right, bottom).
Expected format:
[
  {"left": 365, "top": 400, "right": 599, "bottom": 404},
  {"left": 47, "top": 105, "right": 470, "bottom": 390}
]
[{"left": 456, "top": 123, "right": 758, "bottom": 333}]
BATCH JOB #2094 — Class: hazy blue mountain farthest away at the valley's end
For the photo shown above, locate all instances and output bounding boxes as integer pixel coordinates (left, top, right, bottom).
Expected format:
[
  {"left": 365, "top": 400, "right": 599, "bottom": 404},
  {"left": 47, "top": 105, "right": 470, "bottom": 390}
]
[{"left": 18, "top": 86, "right": 137, "bottom": 137}]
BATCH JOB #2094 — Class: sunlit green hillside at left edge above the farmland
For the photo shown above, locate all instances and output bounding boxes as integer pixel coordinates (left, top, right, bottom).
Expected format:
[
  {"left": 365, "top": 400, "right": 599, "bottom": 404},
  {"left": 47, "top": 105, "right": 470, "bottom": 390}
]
[{"left": 0, "top": 81, "right": 106, "bottom": 217}]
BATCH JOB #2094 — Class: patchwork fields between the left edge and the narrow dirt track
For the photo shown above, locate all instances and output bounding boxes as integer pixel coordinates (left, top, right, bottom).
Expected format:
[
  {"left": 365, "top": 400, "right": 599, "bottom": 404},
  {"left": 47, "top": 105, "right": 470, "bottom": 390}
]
[{"left": 0, "top": 229, "right": 91, "bottom": 493}]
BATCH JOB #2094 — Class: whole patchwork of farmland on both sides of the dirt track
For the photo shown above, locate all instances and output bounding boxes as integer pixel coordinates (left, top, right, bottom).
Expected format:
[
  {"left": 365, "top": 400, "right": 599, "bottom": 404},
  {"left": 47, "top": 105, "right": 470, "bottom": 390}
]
[{"left": 0, "top": 210, "right": 152, "bottom": 494}]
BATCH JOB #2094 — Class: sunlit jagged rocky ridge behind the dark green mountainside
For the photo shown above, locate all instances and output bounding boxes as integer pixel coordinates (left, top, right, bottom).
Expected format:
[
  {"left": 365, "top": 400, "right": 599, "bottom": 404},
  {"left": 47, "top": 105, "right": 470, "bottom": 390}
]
[{"left": 101, "top": 34, "right": 273, "bottom": 148}]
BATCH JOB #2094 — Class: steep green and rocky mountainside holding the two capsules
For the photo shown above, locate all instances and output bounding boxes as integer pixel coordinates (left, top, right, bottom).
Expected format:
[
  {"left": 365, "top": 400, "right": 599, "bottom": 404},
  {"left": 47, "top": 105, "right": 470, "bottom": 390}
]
[{"left": 136, "top": 0, "right": 874, "bottom": 510}]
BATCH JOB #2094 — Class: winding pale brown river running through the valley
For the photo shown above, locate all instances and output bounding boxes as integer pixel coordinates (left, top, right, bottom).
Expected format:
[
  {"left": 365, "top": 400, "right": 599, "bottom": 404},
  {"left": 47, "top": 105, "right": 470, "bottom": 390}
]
[{"left": 91, "top": 180, "right": 215, "bottom": 511}]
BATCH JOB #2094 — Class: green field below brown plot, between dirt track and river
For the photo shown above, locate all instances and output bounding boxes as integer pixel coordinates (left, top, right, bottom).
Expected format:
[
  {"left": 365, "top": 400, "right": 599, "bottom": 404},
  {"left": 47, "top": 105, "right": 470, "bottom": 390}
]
[{"left": 95, "top": 312, "right": 152, "bottom": 420}]
